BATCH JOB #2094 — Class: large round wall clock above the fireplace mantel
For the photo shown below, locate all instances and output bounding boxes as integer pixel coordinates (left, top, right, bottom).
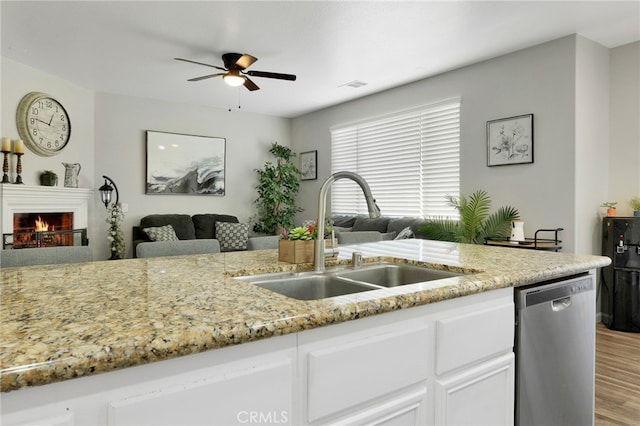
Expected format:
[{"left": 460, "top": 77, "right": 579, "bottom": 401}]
[{"left": 16, "top": 92, "right": 71, "bottom": 157}]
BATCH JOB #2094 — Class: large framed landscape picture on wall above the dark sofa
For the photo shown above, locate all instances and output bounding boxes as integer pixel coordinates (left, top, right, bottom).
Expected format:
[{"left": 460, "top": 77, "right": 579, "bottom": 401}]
[{"left": 145, "top": 130, "right": 226, "bottom": 196}]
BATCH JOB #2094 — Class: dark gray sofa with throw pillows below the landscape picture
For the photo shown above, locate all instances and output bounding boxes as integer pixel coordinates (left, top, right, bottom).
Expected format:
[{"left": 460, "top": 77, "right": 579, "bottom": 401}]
[{"left": 132, "top": 213, "right": 279, "bottom": 257}]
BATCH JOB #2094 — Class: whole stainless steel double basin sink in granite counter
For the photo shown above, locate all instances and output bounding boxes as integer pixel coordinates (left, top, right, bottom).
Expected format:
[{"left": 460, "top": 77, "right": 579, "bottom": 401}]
[{"left": 236, "top": 262, "right": 463, "bottom": 300}]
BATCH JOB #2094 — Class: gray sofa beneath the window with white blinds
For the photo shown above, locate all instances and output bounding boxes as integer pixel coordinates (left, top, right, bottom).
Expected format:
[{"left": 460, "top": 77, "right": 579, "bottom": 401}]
[{"left": 330, "top": 215, "right": 427, "bottom": 245}]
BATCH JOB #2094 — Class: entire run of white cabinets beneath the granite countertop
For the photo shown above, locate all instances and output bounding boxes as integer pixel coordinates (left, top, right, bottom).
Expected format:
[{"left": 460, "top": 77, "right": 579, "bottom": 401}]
[{"left": 1, "top": 288, "right": 514, "bottom": 426}]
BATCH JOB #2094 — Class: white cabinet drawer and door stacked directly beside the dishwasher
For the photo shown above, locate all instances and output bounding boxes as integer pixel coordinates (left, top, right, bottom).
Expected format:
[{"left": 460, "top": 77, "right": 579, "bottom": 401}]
[{"left": 434, "top": 300, "right": 515, "bottom": 426}]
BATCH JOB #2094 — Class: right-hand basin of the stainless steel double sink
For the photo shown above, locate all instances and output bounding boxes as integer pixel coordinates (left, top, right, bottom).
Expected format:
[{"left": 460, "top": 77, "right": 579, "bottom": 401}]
[{"left": 336, "top": 263, "right": 462, "bottom": 287}]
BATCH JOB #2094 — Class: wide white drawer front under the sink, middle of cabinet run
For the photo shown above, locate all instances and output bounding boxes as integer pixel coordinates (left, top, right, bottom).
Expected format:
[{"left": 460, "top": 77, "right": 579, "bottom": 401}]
[{"left": 306, "top": 325, "right": 430, "bottom": 422}]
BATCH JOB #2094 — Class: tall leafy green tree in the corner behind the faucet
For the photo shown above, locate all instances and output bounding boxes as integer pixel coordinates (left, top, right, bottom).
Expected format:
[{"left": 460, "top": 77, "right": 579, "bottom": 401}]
[{"left": 253, "top": 142, "right": 302, "bottom": 235}]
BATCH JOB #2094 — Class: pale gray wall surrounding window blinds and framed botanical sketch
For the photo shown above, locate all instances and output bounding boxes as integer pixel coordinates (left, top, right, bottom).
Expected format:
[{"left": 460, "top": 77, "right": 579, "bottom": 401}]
[{"left": 291, "top": 36, "right": 580, "bottom": 251}]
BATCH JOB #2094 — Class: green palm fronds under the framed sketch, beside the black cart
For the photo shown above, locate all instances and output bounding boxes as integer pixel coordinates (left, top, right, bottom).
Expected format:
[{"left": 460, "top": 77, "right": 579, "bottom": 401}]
[{"left": 418, "top": 190, "right": 520, "bottom": 244}]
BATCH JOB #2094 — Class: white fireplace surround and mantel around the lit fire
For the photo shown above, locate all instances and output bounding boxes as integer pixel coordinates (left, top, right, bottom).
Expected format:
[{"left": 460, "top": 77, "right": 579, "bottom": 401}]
[{"left": 0, "top": 184, "right": 95, "bottom": 234}]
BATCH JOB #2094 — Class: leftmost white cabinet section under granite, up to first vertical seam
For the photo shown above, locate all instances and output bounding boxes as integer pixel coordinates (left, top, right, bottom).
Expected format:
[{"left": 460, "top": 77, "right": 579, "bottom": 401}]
[{"left": 2, "top": 335, "right": 296, "bottom": 426}]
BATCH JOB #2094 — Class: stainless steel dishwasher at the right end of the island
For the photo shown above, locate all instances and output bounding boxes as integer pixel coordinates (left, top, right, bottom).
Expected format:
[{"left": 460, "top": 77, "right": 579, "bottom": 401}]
[{"left": 514, "top": 275, "right": 596, "bottom": 426}]
